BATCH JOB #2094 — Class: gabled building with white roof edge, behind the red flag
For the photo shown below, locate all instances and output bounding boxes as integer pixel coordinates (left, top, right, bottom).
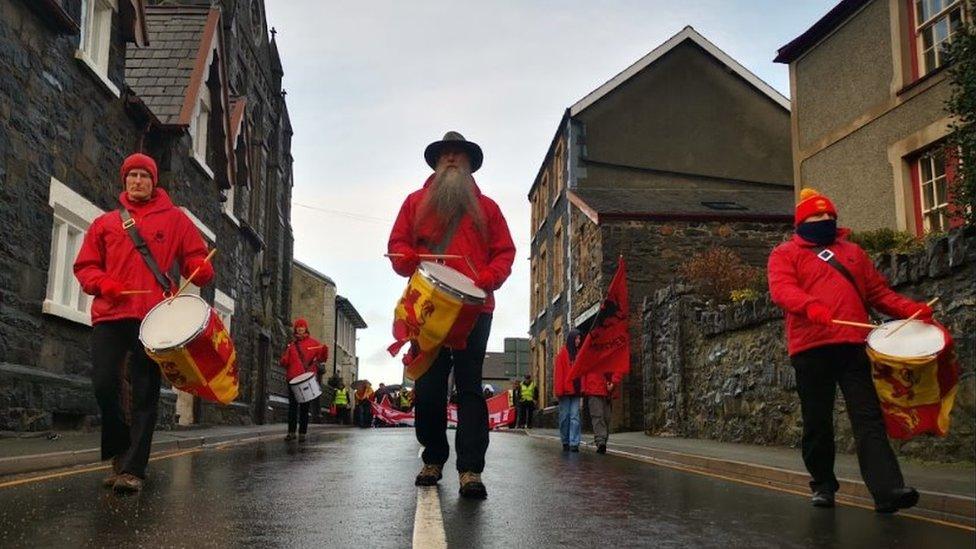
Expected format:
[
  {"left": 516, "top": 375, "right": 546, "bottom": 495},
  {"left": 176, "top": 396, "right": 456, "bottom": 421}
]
[{"left": 528, "top": 27, "right": 793, "bottom": 429}]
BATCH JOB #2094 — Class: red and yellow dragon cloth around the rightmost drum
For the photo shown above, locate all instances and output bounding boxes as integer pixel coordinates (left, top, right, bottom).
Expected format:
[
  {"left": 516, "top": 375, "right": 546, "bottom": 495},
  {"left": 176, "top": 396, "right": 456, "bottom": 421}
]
[{"left": 867, "top": 324, "right": 959, "bottom": 440}]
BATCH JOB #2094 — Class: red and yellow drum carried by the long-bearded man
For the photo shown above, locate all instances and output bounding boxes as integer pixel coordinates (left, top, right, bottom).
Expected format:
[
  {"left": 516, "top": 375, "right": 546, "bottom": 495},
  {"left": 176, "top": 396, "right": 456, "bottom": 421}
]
[{"left": 389, "top": 261, "right": 488, "bottom": 379}]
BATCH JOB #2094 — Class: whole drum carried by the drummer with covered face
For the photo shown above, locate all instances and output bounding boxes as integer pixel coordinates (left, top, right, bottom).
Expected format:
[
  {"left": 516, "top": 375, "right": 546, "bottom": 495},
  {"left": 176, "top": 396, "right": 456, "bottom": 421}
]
[{"left": 867, "top": 320, "right": 956, "bottom": 439}]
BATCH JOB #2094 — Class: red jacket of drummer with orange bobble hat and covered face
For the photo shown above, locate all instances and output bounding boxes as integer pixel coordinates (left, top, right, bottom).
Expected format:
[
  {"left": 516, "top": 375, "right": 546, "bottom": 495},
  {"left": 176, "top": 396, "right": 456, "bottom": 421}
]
[{"left": 769, "top": 229, "right": 921, "bottom": 356}]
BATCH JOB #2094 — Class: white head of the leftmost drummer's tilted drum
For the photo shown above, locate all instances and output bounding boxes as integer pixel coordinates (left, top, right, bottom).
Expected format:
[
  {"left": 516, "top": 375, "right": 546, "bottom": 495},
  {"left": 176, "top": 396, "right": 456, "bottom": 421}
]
[{"left": 139, "top": 294, "right": 210, "bottom": 350}]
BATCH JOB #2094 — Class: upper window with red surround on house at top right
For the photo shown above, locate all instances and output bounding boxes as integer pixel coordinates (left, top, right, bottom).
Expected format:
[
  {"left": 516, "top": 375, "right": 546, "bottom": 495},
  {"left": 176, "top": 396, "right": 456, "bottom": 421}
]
[{"left": 914, "top": 0, "right": 965, "bottom": 76}]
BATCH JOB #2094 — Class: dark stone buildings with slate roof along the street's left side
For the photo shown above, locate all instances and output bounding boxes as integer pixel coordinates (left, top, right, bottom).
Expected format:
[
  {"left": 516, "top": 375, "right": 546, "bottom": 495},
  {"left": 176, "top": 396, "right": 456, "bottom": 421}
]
[{"left": 0, "top": 0, "right": 292, "bottom": 429}]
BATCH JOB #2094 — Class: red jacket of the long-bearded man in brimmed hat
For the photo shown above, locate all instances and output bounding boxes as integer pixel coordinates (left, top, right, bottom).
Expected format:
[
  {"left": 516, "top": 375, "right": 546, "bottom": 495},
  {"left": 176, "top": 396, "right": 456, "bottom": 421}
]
[{"left": 388, "top": 175, "right": 515, "bottom": 312}]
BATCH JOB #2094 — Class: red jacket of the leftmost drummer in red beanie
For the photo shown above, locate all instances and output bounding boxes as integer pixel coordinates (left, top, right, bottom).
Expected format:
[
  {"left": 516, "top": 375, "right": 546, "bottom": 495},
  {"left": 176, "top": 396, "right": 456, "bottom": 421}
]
[{"left": 74, "top": 187, "right": 210, "bottom": 324}]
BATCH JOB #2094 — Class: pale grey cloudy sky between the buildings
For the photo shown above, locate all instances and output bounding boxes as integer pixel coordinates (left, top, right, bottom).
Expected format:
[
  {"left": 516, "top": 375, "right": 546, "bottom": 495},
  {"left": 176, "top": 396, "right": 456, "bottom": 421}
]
[{"left": 266, "top": 0, "right": 836, "bottom": 383}]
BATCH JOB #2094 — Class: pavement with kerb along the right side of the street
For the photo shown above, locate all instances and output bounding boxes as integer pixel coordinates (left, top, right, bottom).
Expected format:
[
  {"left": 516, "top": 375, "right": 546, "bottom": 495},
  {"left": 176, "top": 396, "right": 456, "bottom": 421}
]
[{"left": 526, "top": 429, "right": 976, "bottom": 526}]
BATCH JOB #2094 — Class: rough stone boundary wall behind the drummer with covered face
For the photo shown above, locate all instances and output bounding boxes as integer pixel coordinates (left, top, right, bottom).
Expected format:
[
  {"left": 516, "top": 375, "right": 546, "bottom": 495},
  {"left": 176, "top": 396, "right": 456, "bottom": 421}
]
[{"left": 641, "top": 228, "right": 976, "bottom": 462}]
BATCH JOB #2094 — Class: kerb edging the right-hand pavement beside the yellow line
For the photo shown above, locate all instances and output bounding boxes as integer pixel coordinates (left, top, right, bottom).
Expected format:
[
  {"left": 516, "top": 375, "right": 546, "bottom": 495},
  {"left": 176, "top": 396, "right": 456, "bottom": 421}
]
[{"left": 525, "top": 432, "right": 976, "bottom": 529}]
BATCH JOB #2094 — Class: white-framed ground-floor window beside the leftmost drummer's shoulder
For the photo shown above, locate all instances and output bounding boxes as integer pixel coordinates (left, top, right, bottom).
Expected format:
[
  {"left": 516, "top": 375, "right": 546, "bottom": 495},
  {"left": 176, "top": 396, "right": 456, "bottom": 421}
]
[{"left": 41, "top": 177, "right": 104, "bottom": 326}]
